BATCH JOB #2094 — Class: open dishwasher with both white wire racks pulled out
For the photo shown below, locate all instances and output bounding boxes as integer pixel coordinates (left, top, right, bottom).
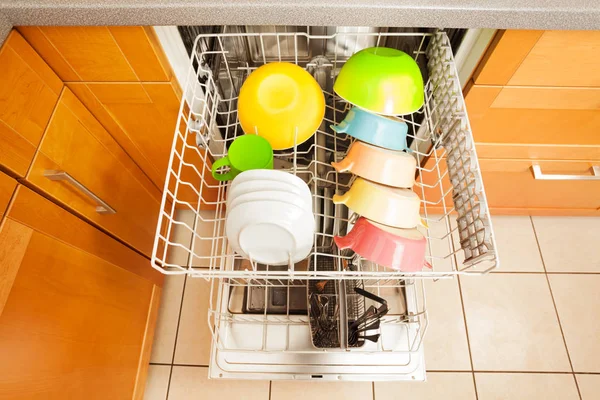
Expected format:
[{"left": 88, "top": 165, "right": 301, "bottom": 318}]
[{"left": 152, "top": 26, "right": 499, "bottom": 381}]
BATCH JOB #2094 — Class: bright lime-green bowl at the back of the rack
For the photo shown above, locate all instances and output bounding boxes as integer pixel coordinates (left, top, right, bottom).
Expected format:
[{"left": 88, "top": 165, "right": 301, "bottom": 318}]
[{"left": 333, "top": 47, "right": 425, "bottom": 115}]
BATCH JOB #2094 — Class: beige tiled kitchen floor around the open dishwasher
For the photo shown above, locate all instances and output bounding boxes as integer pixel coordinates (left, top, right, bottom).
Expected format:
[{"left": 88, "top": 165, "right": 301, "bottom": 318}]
[{"left": 145, "top": 217, "right": 600, "bottom": 400}]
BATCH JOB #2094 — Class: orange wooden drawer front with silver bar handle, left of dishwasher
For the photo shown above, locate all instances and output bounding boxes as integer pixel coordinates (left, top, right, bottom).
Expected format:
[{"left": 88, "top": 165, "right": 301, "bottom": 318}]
[{"left": 26, "top": 88, "right": 161, "bottom": 256}]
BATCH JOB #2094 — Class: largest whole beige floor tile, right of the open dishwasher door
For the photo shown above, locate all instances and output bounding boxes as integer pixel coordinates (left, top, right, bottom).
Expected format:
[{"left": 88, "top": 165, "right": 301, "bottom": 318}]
[{"left": 460, "top": 274, "right": 571, "bottom": 371}]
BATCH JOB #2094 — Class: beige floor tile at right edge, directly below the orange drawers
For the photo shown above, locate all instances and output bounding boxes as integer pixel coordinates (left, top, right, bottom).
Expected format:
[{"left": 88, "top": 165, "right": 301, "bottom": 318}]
[{"left": 533, "top": 217, "right": 600, "bottom": 272}]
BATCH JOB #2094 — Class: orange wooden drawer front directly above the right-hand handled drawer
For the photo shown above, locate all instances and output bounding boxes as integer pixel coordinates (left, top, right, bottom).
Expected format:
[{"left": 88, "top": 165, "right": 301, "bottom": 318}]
[{"left": 465, "top": 85, "right": 600, "bottom": 160}]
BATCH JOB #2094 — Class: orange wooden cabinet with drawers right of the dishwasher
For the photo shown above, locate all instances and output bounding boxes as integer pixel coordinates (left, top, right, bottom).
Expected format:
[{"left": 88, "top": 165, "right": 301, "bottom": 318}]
[{"left": 465, "top": 30, "right": 600, "bottom": 215}]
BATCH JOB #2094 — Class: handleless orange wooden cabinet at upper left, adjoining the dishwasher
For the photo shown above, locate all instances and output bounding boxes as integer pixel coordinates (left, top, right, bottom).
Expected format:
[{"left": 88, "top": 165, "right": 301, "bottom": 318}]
[{"left": 18, "top": 27, "right": 218, "bottom": 209}]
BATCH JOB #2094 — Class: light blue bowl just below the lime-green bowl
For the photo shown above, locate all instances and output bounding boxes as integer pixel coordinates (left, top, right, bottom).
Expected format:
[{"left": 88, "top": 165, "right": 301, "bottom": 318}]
[{"left": 331, "top": 107, "right": 408, "bottom": 151}]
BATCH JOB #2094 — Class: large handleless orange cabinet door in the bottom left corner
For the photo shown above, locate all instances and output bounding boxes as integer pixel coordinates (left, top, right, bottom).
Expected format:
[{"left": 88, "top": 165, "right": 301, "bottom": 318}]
[{"left": 0, "top": 186, "right": 162, "bottom": 399}]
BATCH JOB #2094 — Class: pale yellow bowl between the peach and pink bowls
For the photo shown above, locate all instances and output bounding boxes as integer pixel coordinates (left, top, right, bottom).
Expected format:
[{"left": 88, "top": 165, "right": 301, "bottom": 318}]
[{"left": 333, "top": 178, "right": 421, "bottom": 229}]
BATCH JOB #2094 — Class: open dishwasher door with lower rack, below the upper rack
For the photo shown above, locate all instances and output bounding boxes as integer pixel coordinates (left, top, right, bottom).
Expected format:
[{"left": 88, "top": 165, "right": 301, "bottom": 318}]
[{"left": 210, "top": 258, "right": 427, "bottom": 381}]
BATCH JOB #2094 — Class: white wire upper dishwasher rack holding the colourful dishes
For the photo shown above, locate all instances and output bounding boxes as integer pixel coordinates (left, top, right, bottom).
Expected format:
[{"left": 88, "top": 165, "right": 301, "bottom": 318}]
[{"left": 152, "top": 29, "right": 498, "bottom": 285}]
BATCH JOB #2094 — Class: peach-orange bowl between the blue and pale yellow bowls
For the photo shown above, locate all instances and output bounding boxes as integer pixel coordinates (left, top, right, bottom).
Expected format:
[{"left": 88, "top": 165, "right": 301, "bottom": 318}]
[{"left": 331, "top": 141, "right": 417, "bottom": 188}]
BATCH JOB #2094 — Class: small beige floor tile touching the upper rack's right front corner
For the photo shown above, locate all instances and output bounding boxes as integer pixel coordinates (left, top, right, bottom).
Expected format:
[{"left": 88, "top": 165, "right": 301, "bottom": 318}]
[{"left": 492, "top": 216, "right": 544, "bottom": 272}]
